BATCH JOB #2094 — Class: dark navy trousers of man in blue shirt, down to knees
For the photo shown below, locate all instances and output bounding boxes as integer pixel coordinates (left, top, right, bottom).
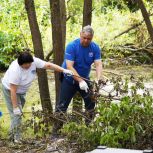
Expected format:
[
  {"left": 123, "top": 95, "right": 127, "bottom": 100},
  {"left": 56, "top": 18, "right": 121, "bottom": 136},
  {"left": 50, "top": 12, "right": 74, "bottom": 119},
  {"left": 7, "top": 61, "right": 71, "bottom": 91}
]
[{"left": 56, "top": 78, "right": 95, "bottom": 112}]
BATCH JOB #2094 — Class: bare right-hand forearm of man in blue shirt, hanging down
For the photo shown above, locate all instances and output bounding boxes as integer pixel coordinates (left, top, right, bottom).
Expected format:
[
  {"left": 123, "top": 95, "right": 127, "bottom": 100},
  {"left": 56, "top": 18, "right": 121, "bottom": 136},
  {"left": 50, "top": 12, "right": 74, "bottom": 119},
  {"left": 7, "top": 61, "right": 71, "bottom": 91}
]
[{"left": 94, "top": 59, "right": 102, "bottom": 81}]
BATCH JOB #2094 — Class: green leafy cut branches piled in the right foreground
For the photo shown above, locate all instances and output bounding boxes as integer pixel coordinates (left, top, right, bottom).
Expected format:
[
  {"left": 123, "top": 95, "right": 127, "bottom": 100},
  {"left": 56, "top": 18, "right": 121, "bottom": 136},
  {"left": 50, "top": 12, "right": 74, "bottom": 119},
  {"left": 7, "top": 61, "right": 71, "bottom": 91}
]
[{"left": 63, "top": 78, "right": 153, "bottom": 152}]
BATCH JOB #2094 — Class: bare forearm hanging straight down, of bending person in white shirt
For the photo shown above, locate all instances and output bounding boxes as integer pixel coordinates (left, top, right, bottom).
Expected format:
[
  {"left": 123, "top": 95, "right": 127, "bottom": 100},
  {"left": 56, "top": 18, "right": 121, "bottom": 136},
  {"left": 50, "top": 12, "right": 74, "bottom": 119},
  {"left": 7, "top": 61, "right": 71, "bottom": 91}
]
[{"left": 10, "top": 84, "right": 18, "bottom": 108}]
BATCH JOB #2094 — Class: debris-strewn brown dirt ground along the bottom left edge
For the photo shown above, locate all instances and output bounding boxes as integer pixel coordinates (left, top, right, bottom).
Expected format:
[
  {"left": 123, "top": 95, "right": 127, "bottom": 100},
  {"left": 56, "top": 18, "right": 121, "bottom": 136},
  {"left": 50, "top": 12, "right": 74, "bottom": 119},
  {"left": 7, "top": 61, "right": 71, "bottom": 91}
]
[{"left": 0, "top": 138, "right": 78, "bottom": 153}]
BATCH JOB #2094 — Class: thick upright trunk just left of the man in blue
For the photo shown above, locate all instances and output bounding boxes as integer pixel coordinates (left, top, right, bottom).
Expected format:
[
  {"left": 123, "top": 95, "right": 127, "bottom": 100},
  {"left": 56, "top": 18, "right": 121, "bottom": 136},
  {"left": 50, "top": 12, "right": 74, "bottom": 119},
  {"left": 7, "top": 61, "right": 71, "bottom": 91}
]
[{"left": 50, "top": 0, "right": 66, "bottom": 104}]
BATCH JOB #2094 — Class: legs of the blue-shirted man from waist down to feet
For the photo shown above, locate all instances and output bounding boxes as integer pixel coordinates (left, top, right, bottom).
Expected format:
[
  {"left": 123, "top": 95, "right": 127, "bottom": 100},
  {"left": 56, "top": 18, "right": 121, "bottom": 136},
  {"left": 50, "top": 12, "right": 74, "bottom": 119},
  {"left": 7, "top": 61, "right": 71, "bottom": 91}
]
[{"left": 52, "top": 78, "right": 95, "bottom": 138}]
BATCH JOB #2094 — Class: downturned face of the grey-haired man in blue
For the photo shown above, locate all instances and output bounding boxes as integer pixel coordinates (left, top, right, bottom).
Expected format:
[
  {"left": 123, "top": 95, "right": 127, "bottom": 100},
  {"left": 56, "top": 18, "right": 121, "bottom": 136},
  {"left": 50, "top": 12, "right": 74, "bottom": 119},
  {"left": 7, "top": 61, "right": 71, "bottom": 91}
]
[{"left": 80, "top": 32, "right": 93, "bottom": 47}]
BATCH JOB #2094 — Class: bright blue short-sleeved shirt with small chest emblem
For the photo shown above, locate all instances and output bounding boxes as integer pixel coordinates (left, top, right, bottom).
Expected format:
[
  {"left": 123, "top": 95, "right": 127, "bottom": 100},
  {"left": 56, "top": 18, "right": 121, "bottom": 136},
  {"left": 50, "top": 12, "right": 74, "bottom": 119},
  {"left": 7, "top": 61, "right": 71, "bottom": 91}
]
[{"left": 62, "top": 39, "right": 101, "bottom": 81}]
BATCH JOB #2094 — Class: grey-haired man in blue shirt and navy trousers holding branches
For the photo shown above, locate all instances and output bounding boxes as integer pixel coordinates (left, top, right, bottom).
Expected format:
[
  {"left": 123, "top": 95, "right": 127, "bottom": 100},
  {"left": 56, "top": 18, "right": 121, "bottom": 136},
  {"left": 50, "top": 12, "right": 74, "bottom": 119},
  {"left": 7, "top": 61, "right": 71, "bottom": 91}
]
[{"left": 52, "top": 25, "right": 102, "bottom": 137}]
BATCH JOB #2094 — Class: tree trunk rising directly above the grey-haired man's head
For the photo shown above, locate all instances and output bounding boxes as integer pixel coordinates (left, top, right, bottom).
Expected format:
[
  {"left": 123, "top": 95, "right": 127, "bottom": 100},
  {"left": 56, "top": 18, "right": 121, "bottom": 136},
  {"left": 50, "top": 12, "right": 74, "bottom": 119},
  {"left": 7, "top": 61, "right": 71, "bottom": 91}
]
[{"left": 83, "top": 0, "right": 92, "bottom": 27}]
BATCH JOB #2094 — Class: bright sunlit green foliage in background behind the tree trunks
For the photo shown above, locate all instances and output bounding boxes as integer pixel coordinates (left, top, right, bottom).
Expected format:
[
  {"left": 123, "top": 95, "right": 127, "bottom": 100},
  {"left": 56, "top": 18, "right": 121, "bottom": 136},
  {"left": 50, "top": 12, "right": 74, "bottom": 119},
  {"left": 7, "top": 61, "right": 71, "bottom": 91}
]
[{"left": 0, "top": 0, "right": 152, "bottom": 66}]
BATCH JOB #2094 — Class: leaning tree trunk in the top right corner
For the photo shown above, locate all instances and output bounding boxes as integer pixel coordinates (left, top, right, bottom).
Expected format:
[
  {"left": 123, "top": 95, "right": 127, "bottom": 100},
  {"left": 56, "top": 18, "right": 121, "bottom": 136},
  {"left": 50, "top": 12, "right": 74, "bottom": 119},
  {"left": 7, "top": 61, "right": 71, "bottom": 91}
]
[{"left": 136, "top": 0, "right": 153, "bottom": 43}]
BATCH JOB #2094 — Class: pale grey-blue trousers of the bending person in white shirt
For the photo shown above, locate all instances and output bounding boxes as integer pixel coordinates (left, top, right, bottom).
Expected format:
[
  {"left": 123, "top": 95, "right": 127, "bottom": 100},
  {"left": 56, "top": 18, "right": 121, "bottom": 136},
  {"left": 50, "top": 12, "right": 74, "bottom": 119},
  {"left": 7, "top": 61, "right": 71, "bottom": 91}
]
[{"left": 2, "top": 85, "right": 25, "bottom": 139}]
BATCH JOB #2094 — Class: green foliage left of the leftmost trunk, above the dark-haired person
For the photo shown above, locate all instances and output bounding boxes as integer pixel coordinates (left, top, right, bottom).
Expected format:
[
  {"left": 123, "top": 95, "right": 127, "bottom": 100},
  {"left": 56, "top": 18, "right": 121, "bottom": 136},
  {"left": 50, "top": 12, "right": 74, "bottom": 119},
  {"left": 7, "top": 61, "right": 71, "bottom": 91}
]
[{"left": 0, "top": 0, "right": 24, "bottom": 69}]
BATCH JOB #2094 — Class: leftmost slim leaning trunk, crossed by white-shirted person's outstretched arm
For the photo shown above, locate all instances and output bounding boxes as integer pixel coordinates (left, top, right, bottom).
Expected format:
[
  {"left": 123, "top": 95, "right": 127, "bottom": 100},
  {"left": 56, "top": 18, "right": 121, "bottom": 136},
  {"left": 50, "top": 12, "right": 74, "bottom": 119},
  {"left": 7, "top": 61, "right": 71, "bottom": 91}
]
[{"left": 25, "top": 0, "right": 52, "bottom": 113}]
